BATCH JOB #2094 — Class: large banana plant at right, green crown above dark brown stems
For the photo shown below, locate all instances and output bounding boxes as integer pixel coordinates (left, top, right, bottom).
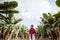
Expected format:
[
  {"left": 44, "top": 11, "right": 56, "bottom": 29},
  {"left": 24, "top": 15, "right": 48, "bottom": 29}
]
[{"left": 39, "top": 12, "right": 60, "bottom": 39}]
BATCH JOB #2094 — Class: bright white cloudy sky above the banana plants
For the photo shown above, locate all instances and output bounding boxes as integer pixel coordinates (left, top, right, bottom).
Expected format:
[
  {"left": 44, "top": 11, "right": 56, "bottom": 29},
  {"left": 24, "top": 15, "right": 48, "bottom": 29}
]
[{"left": 0, "top": 0, "right": 60, "bottom": 28}]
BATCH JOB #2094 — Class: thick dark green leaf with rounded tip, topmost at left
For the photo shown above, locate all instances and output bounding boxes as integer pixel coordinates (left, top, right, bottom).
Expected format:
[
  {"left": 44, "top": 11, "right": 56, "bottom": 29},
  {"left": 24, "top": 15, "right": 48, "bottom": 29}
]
[{"left": 0, "top": 1, "right": 18, "bottom": 10}]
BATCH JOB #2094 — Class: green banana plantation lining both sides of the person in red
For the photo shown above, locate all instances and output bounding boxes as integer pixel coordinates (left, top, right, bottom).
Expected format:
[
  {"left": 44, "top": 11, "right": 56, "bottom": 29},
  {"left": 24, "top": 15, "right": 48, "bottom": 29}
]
[{"left": 0, "top": 0, "right": 60, "bottom": 40}]
